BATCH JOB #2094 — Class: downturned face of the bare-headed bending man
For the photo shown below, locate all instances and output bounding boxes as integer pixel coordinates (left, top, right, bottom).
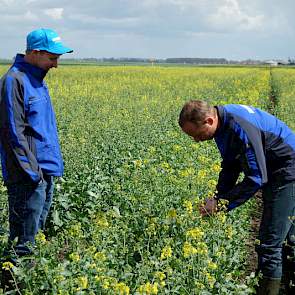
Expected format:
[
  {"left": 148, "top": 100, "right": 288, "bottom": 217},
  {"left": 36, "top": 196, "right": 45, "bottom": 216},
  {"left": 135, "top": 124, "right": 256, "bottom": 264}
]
[{"left": 182, "top": 121, "right": 216, "bottom": 142}]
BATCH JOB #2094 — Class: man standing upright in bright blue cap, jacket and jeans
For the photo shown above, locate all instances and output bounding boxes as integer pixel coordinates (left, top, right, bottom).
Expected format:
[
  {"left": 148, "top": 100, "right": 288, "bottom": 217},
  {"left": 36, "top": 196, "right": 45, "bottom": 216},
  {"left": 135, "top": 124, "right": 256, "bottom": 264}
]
[{"left": 0, "top": 29, "right": 73, "bottom": 278}]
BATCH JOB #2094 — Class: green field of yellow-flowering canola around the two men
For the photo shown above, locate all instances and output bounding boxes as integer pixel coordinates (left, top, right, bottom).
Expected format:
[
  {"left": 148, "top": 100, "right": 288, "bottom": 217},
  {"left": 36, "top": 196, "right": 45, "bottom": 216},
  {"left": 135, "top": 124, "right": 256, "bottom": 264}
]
[{"left": 0, "top": 66, "right": 295, "bottom": 295}]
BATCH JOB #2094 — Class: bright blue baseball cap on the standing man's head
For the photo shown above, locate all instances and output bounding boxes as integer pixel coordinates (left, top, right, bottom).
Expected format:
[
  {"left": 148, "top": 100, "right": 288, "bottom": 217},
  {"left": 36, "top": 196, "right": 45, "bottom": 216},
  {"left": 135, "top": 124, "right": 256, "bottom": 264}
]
[{"left": 27, "top": 29, "right": 73, "bottom": 54}]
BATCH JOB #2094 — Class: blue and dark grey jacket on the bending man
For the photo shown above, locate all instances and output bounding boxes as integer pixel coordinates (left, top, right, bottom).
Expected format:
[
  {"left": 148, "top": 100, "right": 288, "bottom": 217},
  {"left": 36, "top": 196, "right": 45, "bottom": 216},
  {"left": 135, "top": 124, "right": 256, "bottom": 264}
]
[{"left": 214, "top": 104, "right": 295, "bottom": 210}]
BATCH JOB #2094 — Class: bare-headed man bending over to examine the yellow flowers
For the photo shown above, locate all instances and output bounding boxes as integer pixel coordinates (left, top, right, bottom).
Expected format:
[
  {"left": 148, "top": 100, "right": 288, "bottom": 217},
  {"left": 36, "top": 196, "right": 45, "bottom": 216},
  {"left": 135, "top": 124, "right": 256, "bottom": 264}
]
[{"left": 179, "top": 100, "right": 295, "bottom": 295}]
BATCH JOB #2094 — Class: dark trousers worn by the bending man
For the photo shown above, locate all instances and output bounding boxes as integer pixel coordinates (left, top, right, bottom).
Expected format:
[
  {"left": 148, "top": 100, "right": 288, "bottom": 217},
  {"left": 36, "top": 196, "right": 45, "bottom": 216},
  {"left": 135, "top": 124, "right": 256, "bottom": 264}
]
[{"left": 256, "top": 182, "right": 295, "bottom": 278}]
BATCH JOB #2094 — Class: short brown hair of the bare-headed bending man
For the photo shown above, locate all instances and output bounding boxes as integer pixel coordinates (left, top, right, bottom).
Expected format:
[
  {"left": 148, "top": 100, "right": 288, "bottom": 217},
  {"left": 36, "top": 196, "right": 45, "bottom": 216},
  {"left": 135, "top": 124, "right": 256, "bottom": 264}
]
[{"left": 178, "top": 100, "right": 214, "bottom": 127}]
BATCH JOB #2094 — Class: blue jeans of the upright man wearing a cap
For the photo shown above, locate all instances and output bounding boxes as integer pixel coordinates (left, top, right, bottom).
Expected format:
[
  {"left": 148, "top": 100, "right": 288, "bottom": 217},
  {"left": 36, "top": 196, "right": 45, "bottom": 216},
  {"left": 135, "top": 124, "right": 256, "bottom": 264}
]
[{"left": 7, "top": 175, "right": 53, "bottom": 256}]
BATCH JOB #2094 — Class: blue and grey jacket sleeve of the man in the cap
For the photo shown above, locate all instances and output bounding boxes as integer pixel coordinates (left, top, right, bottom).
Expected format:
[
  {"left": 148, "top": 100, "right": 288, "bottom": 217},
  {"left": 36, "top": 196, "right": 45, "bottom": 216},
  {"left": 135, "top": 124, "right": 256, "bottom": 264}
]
[{"left": 1, "top": 75, "right": 43, "bottom": 182}]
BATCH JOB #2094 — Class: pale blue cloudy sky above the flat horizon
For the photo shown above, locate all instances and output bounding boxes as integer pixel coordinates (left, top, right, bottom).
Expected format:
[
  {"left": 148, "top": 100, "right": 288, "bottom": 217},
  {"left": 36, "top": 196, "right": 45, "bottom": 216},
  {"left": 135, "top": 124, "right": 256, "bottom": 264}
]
[{"left": 0, "top": 0, "right": 295, "bottom": 60}]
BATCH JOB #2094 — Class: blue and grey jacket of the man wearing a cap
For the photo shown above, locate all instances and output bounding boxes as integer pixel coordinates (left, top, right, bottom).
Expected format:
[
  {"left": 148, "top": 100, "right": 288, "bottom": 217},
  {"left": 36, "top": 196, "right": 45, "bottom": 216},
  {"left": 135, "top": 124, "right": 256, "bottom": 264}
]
[{"left": 0, "top": 54, "right": 63, "bottom": 184}]
